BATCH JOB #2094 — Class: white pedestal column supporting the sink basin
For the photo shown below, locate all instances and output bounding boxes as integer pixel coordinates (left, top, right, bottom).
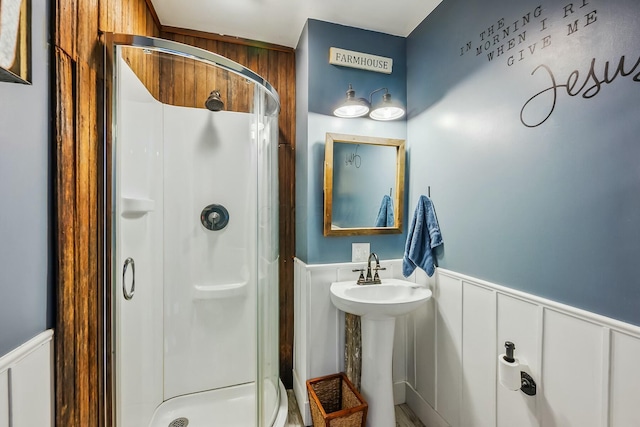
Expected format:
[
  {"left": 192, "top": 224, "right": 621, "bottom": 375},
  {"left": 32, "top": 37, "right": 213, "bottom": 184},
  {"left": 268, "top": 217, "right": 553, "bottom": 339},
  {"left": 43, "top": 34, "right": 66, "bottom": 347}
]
[{"left": 361, "top": 316, "right": 396, "bottom": 427}]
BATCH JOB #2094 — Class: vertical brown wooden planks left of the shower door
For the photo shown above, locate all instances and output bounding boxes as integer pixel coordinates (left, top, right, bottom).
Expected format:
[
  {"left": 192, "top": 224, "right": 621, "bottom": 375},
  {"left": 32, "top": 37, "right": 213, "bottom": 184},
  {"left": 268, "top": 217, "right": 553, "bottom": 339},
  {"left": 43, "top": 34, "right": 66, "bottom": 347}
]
[{"left": 53, "top": 0, "right": 160, "bottom": 427}]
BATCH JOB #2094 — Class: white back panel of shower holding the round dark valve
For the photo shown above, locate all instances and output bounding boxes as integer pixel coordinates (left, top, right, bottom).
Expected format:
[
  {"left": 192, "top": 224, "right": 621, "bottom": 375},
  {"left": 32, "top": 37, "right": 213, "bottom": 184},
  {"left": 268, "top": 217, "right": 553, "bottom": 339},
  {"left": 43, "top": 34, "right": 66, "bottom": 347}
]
[{"left": 164, "top": 106, "right": 257, "bottom": 400}]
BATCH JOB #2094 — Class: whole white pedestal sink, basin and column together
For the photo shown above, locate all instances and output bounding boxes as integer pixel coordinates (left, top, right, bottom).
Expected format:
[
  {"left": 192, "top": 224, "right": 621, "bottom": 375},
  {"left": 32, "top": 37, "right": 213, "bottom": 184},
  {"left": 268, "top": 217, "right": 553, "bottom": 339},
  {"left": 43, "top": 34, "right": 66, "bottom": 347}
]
[{"left": 331, "top": 279, "right": 431, "bottom": 427}]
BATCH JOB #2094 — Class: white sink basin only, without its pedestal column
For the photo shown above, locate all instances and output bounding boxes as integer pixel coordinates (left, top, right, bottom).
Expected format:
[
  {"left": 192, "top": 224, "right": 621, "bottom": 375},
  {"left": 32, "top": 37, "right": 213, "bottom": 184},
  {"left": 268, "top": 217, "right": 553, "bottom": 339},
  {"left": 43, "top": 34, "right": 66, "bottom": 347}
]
[{"left": 331, "top": 279, "right": 431, "bottom": 317}]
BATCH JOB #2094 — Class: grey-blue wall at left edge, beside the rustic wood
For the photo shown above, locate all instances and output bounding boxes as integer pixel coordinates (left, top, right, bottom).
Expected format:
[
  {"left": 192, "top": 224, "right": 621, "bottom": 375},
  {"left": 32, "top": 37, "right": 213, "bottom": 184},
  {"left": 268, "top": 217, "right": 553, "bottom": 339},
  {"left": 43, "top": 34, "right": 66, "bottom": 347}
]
[{"left": 0, "top": 1, "right": 54, "bottom": 356}]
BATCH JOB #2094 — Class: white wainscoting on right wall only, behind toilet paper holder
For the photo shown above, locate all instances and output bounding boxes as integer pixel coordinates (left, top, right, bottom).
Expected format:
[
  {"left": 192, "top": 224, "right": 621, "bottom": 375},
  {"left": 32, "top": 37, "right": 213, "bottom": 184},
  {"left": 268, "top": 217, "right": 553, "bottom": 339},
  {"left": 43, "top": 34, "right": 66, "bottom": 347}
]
[{"left": 406, "top": 268, "right": 640, "bottom": 427}]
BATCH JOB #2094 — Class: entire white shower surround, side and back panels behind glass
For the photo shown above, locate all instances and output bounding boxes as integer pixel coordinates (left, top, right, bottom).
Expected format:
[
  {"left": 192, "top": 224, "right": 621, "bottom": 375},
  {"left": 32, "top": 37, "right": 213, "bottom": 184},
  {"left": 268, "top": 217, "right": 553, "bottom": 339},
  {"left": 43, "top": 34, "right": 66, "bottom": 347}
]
[{"left": 113, "top": 60, "right": 258, "bottom": 427}]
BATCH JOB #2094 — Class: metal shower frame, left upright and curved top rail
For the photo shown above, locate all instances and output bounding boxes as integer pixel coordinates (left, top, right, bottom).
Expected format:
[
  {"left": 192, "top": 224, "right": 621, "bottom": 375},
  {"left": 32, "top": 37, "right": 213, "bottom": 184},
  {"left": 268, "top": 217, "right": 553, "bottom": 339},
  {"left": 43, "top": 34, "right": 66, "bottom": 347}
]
[{"left": 98, "top": 32, "right": 282, "bottom": 427}]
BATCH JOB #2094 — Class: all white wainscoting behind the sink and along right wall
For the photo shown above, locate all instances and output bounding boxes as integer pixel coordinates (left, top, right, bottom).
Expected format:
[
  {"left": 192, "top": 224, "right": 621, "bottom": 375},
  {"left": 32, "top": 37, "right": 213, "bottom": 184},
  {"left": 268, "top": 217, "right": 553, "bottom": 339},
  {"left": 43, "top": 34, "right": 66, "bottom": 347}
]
[{"left": 294, "top": 260, "right": 640, "bottom": 427}]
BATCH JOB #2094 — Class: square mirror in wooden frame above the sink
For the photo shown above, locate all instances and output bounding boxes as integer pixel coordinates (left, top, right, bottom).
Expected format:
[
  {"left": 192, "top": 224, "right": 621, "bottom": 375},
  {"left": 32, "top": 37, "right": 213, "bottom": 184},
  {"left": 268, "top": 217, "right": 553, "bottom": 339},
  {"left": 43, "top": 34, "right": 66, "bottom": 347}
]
[{"left": 324, "top": 133, "right": 405, "bottom": 236}]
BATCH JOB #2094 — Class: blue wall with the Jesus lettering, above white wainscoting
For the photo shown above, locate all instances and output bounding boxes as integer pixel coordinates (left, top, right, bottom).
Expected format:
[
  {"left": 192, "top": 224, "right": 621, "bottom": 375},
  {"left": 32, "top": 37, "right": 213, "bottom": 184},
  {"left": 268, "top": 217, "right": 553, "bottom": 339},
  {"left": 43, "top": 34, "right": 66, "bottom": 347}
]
[{"left": 407, "top": 0, "right": 640, "bottom": 325}]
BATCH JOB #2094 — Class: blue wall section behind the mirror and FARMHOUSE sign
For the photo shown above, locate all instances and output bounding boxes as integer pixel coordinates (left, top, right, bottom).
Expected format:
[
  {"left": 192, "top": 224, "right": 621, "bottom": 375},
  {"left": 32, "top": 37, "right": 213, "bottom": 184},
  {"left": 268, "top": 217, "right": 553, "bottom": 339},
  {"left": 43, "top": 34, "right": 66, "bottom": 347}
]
[{"left": 296, "top": 19, "right": 407, "bottom": 264}]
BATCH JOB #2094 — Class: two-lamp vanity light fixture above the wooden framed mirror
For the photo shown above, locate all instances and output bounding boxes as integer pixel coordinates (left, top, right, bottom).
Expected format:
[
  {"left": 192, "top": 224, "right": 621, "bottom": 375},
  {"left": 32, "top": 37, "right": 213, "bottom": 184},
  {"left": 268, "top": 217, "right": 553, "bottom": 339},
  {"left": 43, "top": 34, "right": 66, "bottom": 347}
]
[{"left": 333, "top": 83, "right": 405, "bottom": 121}]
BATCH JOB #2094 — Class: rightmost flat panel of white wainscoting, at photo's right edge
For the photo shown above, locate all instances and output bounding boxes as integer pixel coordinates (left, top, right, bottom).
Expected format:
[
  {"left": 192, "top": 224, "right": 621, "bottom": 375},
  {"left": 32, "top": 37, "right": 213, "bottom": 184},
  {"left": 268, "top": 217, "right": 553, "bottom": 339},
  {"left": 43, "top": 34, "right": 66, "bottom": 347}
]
[{"left": 609, "top": 332, "right": 640, "bottom": 427}]
